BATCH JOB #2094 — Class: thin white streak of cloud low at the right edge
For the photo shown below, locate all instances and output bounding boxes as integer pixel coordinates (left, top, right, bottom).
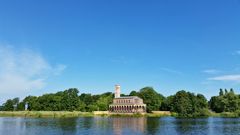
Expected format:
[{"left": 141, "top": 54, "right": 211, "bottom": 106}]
[{"left": 208, "top": 74, "right": 240, "bottom": 82}]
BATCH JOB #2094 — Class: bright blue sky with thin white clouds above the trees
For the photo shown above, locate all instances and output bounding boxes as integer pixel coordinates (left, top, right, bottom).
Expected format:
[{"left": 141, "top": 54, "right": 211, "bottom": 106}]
[{"left": 0, "top": 0, "right": 240, "bottom": 103}]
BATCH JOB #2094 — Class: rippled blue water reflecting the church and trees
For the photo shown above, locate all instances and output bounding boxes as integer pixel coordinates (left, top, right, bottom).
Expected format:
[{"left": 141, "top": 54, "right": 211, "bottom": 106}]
[{"left": 0, "top": 117, "right": 240, "bottom": 135}]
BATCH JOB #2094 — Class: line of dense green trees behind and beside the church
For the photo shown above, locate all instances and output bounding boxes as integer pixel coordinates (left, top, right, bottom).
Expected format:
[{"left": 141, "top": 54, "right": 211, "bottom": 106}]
[{"left": 0, "top": 87, "right": 240, "bottom": 117}]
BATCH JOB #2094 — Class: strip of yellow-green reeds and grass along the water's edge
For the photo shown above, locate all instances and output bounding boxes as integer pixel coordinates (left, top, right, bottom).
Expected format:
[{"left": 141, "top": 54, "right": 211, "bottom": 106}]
[{"left": 0, "top": 111, "right": 240, "bottom": 118}]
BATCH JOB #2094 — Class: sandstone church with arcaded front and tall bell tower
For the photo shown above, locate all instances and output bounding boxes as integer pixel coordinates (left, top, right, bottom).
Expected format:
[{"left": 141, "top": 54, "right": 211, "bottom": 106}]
[{"left": 109, "top": 85, "right": 146, "bottom": 113}]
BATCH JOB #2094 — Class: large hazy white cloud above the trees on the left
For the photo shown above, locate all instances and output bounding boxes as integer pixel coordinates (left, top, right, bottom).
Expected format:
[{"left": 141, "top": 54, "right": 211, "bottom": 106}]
[{"left": 0, "top": 45, "right": 66, "bottom": 98}]
